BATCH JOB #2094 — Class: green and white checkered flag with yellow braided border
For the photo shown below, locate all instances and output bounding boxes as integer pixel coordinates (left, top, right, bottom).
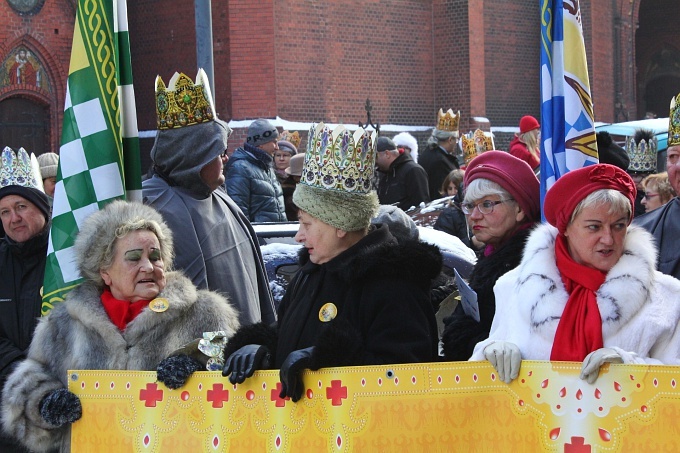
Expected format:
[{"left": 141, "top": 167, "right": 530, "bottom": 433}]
[{"left": 42, "top": 0, "right": 142, "bottom": 316}]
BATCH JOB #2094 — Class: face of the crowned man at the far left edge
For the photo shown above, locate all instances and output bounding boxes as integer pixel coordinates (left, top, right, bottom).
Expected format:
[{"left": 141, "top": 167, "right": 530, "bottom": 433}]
[{"left": 0, "top": 195, "right": 47, "bottom": 242}]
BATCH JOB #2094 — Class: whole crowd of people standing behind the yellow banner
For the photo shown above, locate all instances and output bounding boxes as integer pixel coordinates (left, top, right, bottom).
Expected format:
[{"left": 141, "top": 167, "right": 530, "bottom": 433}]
[{"left": 0, "top": 72, "right": 680, "bottom": 452}]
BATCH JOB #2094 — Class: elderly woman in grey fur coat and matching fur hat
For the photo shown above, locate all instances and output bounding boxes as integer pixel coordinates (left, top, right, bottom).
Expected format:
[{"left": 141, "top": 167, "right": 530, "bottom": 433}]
[{"left": 2, "top": 201, "right": 239, "bottom": 452}]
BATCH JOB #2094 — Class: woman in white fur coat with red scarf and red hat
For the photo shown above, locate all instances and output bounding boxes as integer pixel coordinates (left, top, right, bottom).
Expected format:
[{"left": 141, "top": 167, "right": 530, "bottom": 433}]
[{"left": 470, "top": 164, "right": 680, "bottom": 384}]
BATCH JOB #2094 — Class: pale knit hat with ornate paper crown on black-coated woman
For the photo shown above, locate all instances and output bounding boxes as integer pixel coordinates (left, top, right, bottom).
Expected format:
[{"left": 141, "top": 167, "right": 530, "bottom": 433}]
[{"left": 293, "top": 123, "right": 379, "bottom": 232}]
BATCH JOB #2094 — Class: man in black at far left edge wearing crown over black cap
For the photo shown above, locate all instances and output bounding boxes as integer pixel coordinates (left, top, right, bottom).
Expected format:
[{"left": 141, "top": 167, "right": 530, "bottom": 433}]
[{"left": 0, "top": 148, "right": 50, "bottom": 452}]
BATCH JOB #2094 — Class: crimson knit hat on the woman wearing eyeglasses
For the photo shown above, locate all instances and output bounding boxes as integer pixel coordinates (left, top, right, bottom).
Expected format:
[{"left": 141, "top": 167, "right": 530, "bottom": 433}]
[{"left": 464, "top": 150, "right": 541, "bottom": 222}]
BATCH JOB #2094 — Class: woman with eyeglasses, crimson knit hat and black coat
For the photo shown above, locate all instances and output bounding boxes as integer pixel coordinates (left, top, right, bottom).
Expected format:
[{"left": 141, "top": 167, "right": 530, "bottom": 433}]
[{"left": 442, "top": 151, "right": 540, "bottom": 360}]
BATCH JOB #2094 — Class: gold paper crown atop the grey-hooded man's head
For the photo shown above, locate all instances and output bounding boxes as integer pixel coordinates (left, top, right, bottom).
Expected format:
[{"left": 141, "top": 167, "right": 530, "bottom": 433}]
[{"left": 156, "top": 69, "right": 216, "bottom": 130}]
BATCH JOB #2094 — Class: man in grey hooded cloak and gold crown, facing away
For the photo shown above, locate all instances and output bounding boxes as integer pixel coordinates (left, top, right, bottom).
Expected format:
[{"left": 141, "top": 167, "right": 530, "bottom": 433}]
[{"left": 142, "top": 69, "right": 276, "bottom": 325}]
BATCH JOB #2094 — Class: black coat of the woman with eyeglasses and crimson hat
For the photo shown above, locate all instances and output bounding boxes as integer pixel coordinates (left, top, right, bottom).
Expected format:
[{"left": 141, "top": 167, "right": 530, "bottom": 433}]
[{"left": 442, "top": 228, "right": 531, "bottom": 361}]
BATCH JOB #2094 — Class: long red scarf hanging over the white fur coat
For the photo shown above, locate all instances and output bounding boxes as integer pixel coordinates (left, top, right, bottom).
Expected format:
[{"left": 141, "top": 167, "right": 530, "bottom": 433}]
[{"left": 550, "top": 234, "right": 606, "bottom": 362}]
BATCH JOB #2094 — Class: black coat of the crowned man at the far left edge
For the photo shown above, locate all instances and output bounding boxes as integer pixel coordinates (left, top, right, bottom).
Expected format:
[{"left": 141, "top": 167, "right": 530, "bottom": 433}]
[{"left": 0, "top": 226, "right": 49, "bottom": 452}]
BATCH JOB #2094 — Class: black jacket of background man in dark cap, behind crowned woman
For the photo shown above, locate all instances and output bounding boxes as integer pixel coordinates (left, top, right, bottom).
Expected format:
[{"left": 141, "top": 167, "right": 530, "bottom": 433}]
[{"left": 378, "top": 153, "right": 430, "bottom": 211}]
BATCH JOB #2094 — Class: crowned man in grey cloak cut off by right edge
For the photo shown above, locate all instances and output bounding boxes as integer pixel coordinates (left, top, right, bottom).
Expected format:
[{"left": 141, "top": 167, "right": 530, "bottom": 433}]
[{"left": 633, "top": 94, "right": 680, "bottom": 279}]
